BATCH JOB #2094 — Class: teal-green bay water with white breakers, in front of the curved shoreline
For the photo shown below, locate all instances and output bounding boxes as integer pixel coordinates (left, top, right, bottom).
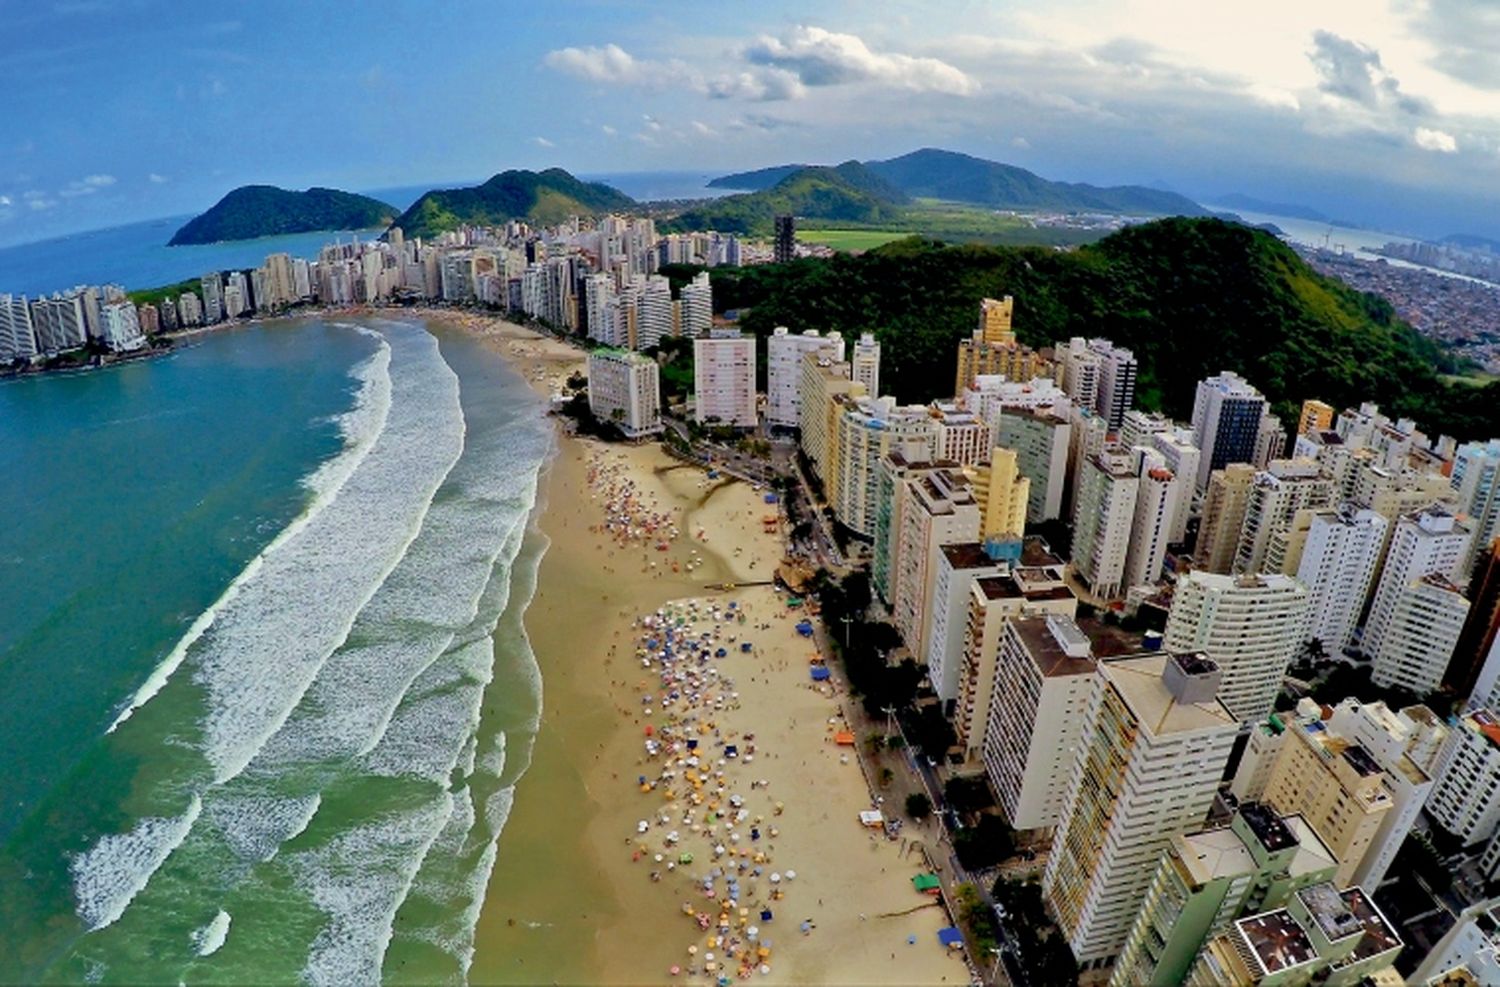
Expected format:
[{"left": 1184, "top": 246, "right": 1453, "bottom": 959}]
[{"left": 0, "top": 318, "right": 554, "bottom": 984}]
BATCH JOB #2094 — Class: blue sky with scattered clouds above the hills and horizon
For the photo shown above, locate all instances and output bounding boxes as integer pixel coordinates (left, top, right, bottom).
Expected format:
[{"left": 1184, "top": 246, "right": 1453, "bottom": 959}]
[{"left": 0, "top": 0, "right": 1500, "bottom": 243}]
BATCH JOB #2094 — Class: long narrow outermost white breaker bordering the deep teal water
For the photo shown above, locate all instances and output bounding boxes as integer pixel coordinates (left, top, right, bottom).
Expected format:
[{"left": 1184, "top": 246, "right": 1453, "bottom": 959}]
[{"left": 105, "top": 330, "right": 392, "bottom": 734}]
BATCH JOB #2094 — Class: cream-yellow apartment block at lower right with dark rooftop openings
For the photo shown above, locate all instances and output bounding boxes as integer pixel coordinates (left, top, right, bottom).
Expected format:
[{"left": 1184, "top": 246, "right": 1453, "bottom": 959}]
[{"left": 1265, "top": 720, "right": 1395, "bottom": 885}]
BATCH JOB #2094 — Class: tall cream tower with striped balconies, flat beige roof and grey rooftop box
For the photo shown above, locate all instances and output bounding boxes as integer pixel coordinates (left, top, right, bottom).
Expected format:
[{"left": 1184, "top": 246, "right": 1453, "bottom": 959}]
[{"left": 1043, "top": 654, "right": 1239, "bottom": 969}]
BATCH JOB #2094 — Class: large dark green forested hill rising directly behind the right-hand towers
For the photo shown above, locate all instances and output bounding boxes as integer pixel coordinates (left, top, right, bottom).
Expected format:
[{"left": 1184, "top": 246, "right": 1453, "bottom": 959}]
[{"left": 668, "top": 218, "right": 1500, "bottom": 440}]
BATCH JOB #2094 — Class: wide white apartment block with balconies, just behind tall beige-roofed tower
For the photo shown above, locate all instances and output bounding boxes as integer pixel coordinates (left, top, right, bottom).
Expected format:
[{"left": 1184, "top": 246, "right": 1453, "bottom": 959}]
[{"left": 1164, "top": 572, "right": 1308, "bottom": 722}]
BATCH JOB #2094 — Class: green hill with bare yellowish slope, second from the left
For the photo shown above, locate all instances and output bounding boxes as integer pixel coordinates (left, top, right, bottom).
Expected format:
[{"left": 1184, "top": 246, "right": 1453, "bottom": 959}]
[{"left": 392, "top": 168, "right": 636, "bottom": 237}]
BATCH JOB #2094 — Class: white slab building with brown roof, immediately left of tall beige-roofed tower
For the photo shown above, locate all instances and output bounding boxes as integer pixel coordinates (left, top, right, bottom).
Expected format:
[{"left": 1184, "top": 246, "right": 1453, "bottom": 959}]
[{"left": 983, "top": 614, "right": 1097, "bottom": 830}]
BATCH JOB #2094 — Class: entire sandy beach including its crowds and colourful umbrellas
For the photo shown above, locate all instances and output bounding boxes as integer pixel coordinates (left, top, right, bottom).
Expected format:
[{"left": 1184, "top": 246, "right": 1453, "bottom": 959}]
[{"left": 429, "top": 312, "right": 968, "bottom": 984}]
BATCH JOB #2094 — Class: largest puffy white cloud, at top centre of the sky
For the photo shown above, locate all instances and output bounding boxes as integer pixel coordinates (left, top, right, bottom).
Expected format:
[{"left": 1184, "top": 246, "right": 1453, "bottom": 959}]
[{"left": 744, "top": 24, "right": 980, "bottom": 96}]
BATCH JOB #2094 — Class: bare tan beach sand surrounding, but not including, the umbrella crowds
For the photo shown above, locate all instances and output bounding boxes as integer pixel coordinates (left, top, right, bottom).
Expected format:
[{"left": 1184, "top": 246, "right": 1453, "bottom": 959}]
[{"left": 435, "top": 309, "right": 968, "bottom": 984}]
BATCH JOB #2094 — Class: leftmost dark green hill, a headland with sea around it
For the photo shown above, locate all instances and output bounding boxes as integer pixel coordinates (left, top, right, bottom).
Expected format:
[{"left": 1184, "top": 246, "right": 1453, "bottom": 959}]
[{"left": 168, "top": 185, "right": 398, "bottom": 246}]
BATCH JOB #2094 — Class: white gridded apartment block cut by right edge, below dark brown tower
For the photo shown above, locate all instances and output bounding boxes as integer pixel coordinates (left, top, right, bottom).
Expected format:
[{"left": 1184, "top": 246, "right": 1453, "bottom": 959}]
[{"left": 1427, "top": 710, "right": 1500, "bottom": 846}]
